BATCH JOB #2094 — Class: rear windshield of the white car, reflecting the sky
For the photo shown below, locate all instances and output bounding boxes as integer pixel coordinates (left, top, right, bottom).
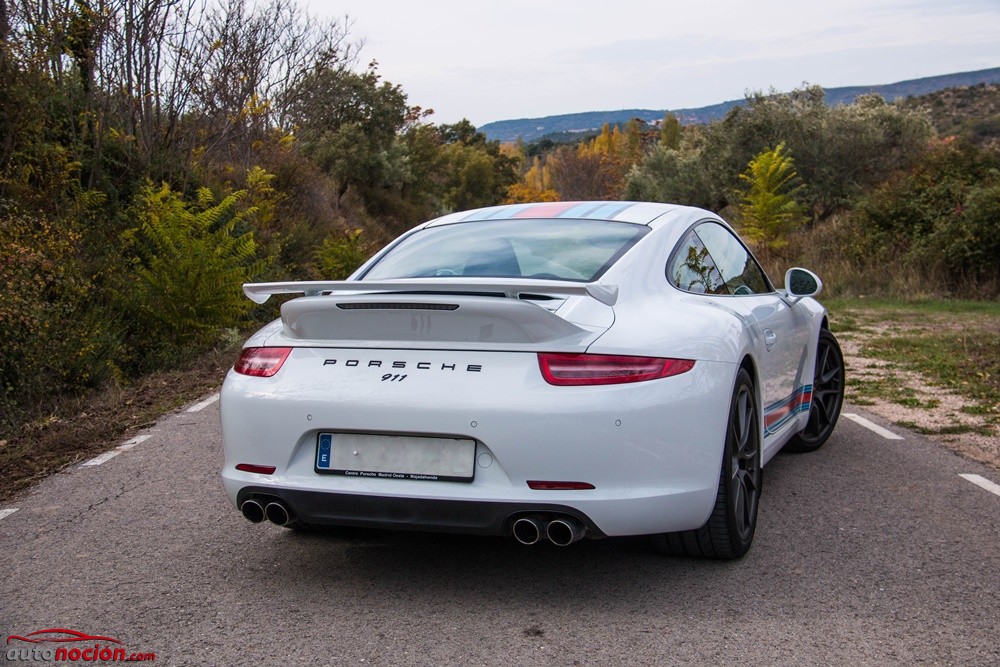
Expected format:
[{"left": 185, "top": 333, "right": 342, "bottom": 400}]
[{"left": 362, "top": 220, "right": 649, "bottom": 282}]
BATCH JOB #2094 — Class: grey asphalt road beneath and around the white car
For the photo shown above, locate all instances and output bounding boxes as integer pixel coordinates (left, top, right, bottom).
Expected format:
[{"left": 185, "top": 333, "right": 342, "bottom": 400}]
[{"left": 0, "top": 403, "right": 1000, "bottom": 666}]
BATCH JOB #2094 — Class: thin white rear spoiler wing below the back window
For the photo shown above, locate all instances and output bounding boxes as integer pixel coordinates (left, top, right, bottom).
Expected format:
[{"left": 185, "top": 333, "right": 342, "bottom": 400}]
[{"left": 243, "top": 278, "right": 618, "bottom": 306}]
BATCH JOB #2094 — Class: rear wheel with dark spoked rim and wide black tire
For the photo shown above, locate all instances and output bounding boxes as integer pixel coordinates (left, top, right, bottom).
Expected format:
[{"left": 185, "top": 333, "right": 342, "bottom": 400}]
[{"left": 653, "top": 368, "right": 764, "bottom": 559}]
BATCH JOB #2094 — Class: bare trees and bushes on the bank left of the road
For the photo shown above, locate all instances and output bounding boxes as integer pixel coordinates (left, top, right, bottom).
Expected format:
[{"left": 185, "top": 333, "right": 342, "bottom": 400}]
[{"left": 0, "top": 0, "right": 518, "bottom": 440}]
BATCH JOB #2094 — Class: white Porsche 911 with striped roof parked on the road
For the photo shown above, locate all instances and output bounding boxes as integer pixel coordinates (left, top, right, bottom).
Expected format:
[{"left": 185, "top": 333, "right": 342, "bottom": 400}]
[{"left": 221, "top": 202, "right": 844, "bottom": 558}]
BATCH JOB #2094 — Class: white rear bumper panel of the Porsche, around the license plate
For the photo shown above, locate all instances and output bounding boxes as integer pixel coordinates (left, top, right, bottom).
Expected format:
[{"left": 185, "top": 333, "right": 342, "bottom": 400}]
[{"left": 221, "top": 348, "right": 735, "bottom": 536}]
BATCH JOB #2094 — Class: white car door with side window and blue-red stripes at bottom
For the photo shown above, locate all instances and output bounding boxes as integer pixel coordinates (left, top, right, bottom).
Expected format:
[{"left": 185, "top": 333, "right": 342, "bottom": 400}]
[{"left": 680, "top": 221, "right": 810, "bottom": 438}]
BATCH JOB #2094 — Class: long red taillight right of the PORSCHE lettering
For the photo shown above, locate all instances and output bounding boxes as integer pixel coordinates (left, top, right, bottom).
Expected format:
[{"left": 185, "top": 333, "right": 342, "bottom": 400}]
[{"left": 538, "top": 352, "right": 694, "bottom": 386}]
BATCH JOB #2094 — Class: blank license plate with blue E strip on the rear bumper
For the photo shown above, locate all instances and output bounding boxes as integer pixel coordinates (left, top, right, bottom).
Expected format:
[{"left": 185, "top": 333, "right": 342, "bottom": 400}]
[{"left": 316, "top": 433, "right": 476, "bottom": 482}]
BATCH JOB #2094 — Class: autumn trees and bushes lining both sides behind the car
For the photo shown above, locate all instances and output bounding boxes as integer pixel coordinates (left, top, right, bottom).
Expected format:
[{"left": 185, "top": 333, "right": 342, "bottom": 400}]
[{"left": 0, "top": 0, "right": 1000, "bottom": 496}]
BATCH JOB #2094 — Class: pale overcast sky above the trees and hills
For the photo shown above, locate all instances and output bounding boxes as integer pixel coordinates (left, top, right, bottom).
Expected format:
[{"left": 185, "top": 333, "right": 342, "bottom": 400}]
[{"left": 299, "top": 0, "right": 1000, "bottom": 126}]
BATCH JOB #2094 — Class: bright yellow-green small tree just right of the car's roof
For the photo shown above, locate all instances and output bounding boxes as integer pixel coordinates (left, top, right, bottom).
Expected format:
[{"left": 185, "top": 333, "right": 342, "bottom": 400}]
[{"left": 737, "top": 143, "right": 806, "bottom": 252}]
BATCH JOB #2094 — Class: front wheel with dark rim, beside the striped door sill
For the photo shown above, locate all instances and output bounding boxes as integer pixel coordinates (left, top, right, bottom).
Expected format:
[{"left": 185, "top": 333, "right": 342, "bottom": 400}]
[{"left": 785, "top": 329, "right": 844, "bottom": 453}]
